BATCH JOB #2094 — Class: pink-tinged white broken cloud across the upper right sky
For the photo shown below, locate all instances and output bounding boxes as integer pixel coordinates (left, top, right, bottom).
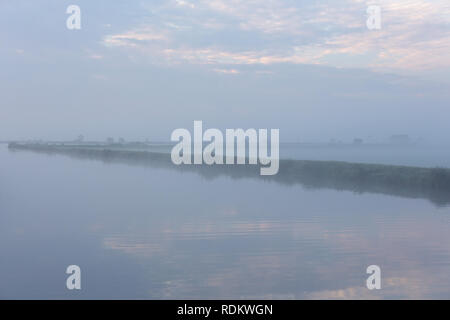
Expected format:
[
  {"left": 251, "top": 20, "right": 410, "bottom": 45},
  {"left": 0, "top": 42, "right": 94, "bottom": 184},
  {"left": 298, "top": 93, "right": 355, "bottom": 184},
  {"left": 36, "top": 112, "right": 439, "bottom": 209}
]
[{"left": 102, "top": 0, "right": 450, "bottom": 71}]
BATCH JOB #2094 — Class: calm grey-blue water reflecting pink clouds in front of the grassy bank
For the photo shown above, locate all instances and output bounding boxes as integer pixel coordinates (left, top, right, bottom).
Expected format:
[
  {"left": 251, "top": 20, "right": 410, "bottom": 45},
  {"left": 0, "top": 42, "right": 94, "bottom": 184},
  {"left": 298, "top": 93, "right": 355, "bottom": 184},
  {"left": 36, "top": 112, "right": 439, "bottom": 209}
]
[{"left": 0, "top": 145, "right": 450, "bottom": 299}]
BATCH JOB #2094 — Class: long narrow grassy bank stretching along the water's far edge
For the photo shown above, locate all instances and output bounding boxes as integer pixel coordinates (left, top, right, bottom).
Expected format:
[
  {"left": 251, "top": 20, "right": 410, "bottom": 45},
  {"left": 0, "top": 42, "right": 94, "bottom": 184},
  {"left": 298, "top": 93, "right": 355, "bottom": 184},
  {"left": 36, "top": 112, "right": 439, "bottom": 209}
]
[{"left": 9, "top": 143, "right": 450, "bottom": 205}]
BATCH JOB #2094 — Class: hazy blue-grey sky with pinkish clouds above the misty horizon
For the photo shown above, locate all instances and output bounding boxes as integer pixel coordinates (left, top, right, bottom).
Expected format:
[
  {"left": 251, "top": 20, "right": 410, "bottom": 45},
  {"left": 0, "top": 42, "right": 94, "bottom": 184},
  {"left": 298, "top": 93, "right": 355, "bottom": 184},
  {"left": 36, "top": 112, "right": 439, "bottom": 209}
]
[{"left": 0, "top": 0, "right": 450, "bottom": 143}]
